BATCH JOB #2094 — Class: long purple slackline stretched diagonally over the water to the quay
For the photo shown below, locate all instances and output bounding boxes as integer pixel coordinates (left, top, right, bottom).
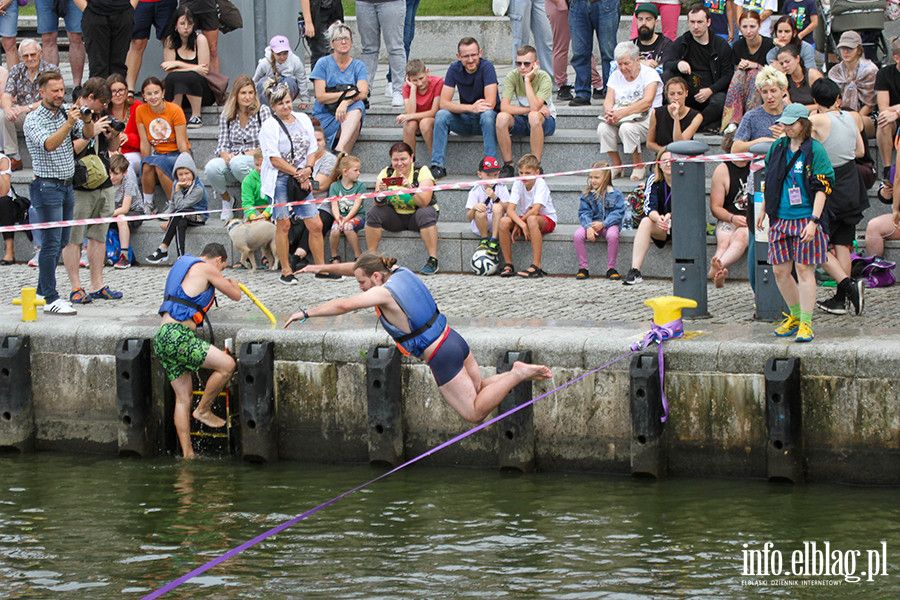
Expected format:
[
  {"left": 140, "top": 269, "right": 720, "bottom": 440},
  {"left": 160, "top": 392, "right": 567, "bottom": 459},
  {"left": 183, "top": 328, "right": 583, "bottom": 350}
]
[{"left": 141, "top": 350, "right": 640, "bottom": 600}]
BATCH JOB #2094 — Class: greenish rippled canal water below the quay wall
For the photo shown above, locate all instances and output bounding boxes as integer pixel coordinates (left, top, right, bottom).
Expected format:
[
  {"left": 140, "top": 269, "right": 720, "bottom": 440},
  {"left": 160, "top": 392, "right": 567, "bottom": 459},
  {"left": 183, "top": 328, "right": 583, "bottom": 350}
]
[{"left": 0, "top": 453, "right": 900, "bottom": 600}]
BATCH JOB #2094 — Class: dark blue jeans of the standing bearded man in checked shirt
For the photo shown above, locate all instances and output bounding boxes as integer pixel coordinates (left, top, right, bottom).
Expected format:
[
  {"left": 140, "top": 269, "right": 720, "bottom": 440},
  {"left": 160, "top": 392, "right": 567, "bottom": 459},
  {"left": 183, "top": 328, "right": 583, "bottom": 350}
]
[{"left": 31, "top": 179, "right": 75, "bottom": 304}]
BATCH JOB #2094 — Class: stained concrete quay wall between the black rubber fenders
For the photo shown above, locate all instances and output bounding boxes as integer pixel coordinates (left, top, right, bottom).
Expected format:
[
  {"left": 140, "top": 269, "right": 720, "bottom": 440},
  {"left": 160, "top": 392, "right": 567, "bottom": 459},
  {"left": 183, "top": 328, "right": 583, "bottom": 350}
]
[{"left": 7, "top": 317, "right": 900, "bottom": 485}]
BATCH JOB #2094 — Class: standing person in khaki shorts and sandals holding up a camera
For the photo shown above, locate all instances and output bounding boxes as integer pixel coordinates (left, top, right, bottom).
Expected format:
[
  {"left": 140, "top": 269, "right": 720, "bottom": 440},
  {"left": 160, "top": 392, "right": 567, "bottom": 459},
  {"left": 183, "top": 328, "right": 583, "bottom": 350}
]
[{"left": 62, "top": 77, "right": 122, "bottom": 304}]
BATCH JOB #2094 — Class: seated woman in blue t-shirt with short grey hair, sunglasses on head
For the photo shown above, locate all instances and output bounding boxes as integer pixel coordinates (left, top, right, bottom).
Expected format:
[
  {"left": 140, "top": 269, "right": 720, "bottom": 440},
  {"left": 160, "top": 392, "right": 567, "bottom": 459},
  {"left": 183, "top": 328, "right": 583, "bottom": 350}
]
[{"left": 309, "top": 21, "right": 369, "bottom": 154}]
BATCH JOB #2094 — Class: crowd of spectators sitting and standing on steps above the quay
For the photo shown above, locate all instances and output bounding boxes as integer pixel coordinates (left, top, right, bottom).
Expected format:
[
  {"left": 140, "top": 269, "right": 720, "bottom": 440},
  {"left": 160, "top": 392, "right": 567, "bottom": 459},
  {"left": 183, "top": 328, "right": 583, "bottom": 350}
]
[{"left": 0, "top": 0, "right": 900, "bottom": 341}]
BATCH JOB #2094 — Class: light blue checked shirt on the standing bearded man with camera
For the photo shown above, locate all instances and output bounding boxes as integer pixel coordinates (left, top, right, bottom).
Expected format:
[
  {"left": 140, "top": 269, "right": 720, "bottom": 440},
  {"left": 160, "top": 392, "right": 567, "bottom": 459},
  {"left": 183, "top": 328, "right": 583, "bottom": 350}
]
[{"left": 22, "top": 102, "right": 87, "bottom": 179}]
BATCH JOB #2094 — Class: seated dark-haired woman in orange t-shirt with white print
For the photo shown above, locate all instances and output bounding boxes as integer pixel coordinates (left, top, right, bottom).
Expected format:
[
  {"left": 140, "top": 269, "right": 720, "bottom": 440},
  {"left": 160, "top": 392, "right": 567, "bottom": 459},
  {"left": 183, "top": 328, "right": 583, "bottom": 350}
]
[{"left": 134, "top": 77, "right": 191, "bottom": 207}]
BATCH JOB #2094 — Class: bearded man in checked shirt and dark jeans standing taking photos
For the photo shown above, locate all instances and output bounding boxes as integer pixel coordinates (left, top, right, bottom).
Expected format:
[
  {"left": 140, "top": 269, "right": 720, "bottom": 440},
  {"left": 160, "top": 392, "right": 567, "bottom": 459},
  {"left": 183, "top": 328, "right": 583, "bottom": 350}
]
[{"left": 23, "top": 71, "right": 102, "bottom": 315}]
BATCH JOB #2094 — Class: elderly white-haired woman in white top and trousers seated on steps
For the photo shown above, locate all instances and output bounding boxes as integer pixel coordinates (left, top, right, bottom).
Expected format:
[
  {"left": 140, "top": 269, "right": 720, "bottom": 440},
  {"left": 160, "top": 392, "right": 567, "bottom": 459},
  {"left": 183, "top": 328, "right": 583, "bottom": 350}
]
[{"left": 597, "top": 42, "right": 663, "bottom": 181}]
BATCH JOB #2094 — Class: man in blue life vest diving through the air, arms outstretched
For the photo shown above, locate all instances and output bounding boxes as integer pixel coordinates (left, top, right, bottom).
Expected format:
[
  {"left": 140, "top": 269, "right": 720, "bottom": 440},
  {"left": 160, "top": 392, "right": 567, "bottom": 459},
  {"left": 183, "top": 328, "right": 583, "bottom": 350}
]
[{"left": 284, "top": 252, "right": 553, "bottom": 423}]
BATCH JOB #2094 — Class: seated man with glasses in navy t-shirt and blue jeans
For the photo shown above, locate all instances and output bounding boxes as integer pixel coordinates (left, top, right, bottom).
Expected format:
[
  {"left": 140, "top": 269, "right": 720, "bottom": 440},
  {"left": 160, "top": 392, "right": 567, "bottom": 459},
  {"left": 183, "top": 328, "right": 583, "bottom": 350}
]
[{"left": 431, "top": 38, "right": 499, "bottom": 179}]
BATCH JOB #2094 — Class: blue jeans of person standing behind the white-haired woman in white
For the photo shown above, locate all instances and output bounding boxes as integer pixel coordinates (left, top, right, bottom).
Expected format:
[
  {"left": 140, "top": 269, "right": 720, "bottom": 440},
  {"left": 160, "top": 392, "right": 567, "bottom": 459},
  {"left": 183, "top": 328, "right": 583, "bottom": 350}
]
[{"left": 569, "top": 0, "right": 621, "bottom": 100}]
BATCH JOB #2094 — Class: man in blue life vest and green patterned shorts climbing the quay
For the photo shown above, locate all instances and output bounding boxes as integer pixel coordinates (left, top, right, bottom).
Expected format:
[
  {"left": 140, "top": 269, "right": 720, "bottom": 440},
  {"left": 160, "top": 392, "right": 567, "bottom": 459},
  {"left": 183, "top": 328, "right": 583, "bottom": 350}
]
[{"left": 153, "top": 243, "right": 241, "bottom": 458}]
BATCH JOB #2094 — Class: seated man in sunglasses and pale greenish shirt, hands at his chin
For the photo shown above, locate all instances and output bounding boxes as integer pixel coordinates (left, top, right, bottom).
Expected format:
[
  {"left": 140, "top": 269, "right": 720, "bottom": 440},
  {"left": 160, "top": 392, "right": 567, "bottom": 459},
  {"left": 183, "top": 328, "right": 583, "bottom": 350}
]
[{"left": 497, "top": 46, "right": 556, "bottom": 177}]
